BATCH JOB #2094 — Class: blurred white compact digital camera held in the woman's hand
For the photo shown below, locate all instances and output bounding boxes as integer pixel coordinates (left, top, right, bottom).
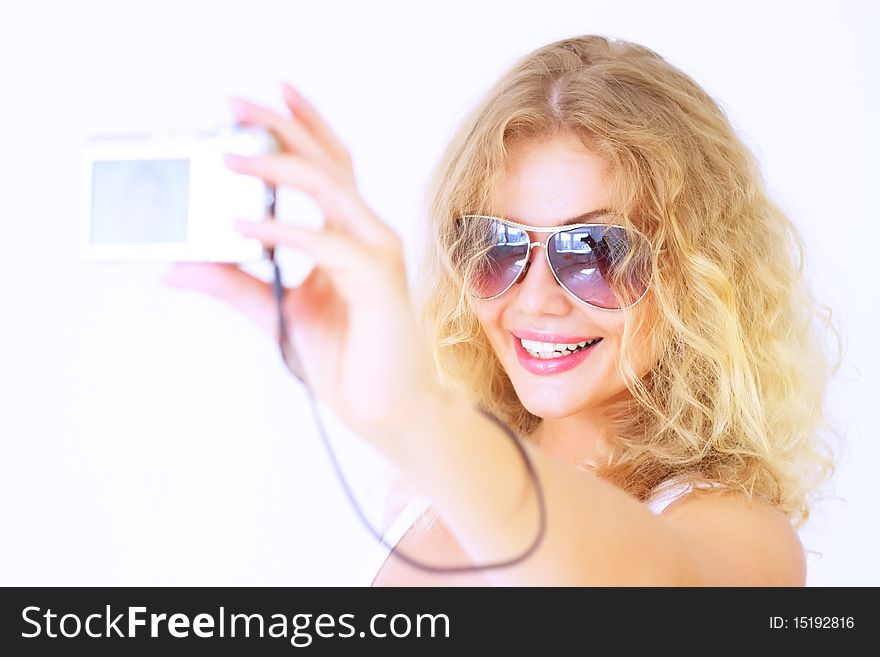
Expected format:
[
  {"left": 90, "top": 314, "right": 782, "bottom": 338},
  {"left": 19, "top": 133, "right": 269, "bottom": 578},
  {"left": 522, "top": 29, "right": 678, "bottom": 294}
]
[{"left": 80, "top": 126, "right": 278, "bottom": 263}]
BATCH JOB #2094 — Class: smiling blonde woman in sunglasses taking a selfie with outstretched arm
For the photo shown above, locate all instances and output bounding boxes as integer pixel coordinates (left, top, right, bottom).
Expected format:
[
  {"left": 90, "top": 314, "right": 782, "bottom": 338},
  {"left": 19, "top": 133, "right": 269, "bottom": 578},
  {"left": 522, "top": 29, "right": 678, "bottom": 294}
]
[{"left": 167, "top": 36, "right": 832, "bottom": 585}]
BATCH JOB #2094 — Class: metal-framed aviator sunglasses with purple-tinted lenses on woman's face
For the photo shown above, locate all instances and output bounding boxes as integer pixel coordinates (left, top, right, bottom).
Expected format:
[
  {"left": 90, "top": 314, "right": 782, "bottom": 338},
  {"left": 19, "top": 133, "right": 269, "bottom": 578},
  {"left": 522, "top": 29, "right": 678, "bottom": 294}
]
[{"left": 460, "top": 211, "right": 651, "bottom": 310}]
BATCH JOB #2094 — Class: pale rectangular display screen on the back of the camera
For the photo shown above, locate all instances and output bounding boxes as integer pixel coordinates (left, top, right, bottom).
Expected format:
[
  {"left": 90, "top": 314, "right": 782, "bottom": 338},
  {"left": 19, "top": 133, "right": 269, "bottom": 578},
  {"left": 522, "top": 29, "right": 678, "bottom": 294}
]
[{"left": 91, "top": 160, "right": 189, "bottom": 244}]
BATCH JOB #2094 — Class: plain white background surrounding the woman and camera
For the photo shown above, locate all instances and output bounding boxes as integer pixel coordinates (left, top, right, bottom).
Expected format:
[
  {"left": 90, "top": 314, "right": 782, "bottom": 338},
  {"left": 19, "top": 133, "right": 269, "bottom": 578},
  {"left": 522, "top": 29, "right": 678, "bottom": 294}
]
[{"left": 0, "top": 0, "right": 880, "bottom": 585}]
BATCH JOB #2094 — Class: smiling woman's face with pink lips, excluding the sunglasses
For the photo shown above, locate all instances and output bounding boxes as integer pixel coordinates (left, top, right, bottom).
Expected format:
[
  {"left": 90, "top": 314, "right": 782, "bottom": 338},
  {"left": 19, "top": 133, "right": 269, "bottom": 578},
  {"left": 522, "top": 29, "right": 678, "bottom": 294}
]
[{"left": 474, "top": 135, "right": 648, "bottom": 419}]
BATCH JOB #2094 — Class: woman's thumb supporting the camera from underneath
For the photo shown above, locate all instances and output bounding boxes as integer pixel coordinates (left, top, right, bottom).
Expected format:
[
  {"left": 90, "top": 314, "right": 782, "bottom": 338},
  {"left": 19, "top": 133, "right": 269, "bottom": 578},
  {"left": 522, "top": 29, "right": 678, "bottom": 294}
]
[{"left": 161, "top": 262, "right": 278, "bottom": 338}]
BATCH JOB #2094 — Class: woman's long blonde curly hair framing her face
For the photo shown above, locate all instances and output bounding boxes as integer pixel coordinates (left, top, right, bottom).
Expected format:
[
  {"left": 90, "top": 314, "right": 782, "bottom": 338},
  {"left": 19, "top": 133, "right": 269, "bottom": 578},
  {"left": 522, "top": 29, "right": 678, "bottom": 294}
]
[{"left": 414, "top": 36, "right": 839, "bottom": 526}]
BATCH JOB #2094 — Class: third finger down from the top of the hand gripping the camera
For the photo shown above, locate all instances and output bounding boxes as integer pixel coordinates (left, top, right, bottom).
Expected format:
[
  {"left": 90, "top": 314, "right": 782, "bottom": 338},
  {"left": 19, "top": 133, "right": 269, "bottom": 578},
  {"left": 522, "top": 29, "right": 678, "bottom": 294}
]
[{"left": 224, "top": 153, "right": 397, "bottom": 245}]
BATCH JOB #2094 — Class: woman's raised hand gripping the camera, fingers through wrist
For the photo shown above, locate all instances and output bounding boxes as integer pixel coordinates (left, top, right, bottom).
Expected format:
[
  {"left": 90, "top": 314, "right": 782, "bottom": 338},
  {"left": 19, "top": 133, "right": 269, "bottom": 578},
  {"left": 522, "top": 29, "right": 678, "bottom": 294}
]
[{"left": 164, "top": 85, "right": 442, "bottom": 450}]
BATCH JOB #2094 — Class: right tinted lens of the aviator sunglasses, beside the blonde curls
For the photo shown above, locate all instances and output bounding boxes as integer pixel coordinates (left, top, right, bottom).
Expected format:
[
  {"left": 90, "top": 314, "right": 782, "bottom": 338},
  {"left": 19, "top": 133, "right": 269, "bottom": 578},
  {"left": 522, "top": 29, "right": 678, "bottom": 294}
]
[{"left": 547, "top": 225, "right": 651, "bottom": 310}]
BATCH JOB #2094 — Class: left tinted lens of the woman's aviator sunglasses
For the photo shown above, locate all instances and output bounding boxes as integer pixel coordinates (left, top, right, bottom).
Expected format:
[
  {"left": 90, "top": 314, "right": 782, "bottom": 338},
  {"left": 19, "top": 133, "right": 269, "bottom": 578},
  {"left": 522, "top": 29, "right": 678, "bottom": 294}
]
[{"left": 471, "top": 221, "right": 529, "bottom": 299}]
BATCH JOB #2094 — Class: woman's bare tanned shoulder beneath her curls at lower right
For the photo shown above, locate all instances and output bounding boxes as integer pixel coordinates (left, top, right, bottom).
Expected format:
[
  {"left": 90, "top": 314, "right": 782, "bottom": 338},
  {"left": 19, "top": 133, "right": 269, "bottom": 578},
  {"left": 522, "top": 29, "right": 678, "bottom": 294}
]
[{"left": 661, "top": 490, "right": 806, "bottom": 586}]
